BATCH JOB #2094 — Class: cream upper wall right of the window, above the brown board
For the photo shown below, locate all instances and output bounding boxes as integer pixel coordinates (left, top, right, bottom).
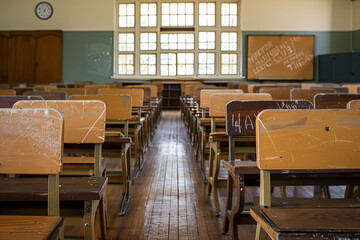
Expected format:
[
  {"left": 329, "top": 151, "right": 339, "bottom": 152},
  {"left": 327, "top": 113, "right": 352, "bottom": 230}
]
[{"left": 242, "top": 0, "right": 352, "bottom": 31}]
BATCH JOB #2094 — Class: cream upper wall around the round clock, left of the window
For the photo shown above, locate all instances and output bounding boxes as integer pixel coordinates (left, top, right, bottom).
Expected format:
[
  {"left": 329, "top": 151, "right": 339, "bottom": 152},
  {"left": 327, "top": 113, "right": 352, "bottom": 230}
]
[{"left": 0, "top": 0, "right": 115, "bottom": 31}]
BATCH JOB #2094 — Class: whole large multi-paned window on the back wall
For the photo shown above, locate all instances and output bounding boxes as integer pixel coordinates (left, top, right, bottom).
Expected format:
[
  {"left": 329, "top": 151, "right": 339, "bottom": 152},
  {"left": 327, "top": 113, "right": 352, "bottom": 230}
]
[{"left": 115, "top": 0, "right": 241, "bottom": 78}]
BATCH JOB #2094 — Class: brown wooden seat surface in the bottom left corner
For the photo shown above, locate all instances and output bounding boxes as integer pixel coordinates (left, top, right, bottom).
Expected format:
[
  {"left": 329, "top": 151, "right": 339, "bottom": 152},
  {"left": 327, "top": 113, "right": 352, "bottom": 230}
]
[{"left": 0, "top": 215, "right": 64, "bottom": 240}]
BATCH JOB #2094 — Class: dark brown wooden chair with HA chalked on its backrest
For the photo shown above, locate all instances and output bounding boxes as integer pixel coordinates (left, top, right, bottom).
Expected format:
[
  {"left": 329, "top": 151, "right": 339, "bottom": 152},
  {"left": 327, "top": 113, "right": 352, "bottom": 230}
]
[{"left": 223, "top": 100, "right": 313, "bottom": 239}]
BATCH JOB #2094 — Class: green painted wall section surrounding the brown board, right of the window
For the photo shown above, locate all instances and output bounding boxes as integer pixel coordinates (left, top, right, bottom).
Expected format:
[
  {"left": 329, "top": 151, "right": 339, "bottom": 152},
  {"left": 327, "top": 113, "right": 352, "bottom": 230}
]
[{"left": 242, "top": 31, "right": 352, "bottom": 80}]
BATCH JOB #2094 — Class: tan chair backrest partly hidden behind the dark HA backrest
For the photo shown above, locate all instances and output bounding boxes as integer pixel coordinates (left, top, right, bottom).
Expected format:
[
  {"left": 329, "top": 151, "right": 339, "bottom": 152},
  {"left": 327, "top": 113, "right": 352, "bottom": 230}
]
[{"left": 209, "top": 93, "right": 271, "bottom": 118}]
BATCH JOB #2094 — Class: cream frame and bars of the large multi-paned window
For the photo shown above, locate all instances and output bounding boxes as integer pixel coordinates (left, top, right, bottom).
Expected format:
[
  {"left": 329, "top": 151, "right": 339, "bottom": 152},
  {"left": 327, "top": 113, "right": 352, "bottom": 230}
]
[{"left": 112, "top": 0, "right": 243, "bottom": 79}]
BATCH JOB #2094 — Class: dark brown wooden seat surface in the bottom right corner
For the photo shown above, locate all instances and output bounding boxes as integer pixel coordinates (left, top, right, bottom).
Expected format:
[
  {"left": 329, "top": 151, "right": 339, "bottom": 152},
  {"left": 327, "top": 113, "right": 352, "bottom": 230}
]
[{"left": 250, "top": 207, "right": 360, "bottom": 240}]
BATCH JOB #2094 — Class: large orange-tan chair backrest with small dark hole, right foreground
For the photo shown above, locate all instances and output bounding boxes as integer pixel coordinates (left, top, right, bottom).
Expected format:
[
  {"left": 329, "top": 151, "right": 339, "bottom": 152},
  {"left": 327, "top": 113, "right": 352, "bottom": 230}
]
[{"left": 256, "top": 109, "right": 360, "bottom": 170}]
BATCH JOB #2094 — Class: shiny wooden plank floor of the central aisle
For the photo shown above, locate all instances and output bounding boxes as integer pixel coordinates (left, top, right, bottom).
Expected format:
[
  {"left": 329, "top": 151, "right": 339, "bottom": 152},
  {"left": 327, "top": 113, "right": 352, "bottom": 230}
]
[{"left": 65, "top": 111, "right": 343, "bottom": 240}]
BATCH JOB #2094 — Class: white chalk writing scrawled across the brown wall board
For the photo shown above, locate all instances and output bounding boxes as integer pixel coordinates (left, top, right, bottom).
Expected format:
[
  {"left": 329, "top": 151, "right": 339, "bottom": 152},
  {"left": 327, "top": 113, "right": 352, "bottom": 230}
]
[{"left": 248, "top": 36, "right": 313, "bottom": 75}]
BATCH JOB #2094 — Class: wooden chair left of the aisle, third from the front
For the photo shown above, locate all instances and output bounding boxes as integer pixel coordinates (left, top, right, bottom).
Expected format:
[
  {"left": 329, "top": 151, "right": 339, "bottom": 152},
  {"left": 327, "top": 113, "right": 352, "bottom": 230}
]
[{"left": 70, "top": 94, "right": 133, "bottom": 215}]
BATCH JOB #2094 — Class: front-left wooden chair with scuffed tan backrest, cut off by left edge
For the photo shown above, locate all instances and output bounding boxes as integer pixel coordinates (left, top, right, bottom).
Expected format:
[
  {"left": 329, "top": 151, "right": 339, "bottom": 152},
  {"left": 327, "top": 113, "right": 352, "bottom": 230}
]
[{"left": 0, "top": 108, "right": 64, "bottom": 239}]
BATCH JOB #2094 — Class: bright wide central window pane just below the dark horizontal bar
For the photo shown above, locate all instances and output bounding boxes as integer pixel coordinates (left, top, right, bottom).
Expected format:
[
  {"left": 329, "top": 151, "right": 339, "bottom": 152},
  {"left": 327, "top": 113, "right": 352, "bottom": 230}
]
[{"left": 160, "top": 33, "right": 194, "bottom": 50}]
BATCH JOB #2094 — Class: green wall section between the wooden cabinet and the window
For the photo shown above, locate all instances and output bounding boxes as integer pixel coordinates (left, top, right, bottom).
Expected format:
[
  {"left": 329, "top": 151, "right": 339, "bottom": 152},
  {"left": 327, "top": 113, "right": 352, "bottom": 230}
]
[{"left": 62, "top": 31, "right": 114, "bottom": 83}]
